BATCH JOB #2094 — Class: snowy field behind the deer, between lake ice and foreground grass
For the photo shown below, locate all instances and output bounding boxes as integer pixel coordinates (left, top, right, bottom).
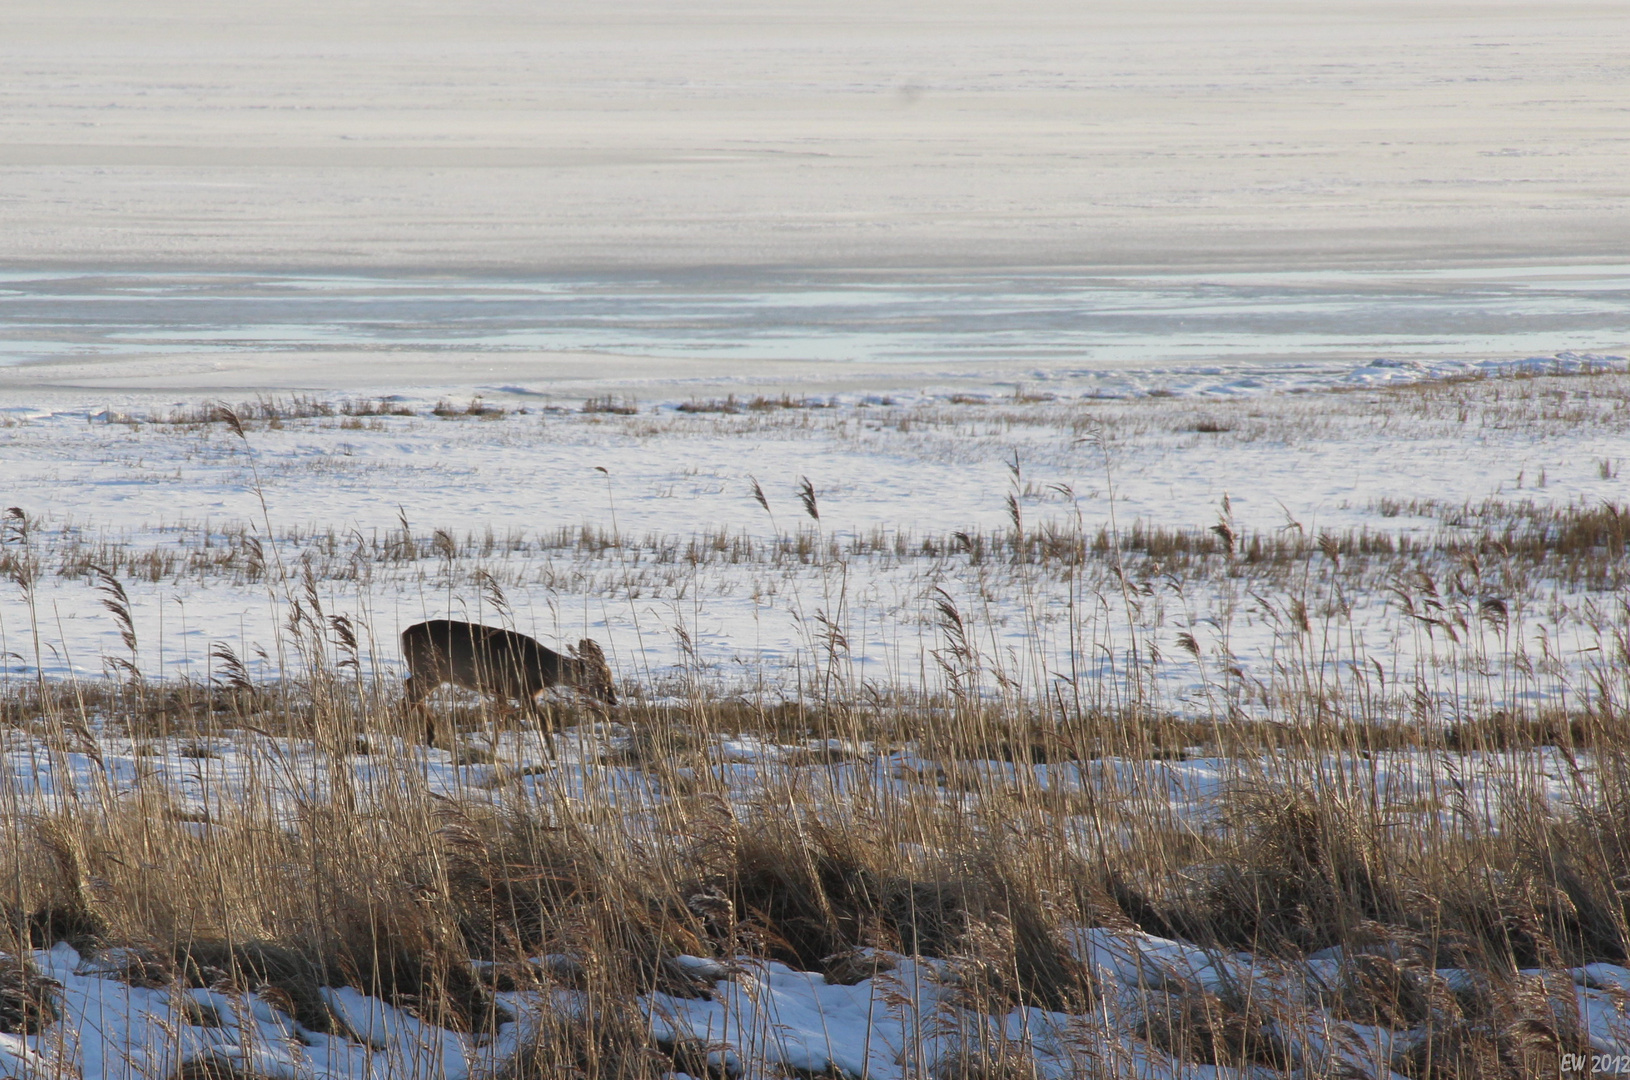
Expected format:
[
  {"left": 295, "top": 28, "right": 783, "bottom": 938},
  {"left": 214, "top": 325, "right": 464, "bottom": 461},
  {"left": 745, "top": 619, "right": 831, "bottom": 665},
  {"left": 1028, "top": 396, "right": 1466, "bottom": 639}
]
[{"left": 0, "top": 353, "right": 1625, "bottom": 713}]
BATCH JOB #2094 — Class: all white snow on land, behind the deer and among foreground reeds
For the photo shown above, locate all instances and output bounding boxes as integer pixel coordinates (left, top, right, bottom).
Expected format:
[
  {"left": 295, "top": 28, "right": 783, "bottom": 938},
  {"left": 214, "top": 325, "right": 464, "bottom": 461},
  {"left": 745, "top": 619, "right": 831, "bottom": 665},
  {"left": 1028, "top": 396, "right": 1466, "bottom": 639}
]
[{"left": 0, "top": 355, "right": 1630, "bottom": 1077}]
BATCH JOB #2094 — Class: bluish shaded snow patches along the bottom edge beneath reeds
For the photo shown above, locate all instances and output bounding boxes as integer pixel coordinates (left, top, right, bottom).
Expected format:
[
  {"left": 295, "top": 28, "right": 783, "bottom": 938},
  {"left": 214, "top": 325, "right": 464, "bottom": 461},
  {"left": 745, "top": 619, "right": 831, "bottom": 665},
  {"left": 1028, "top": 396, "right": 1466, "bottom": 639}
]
[{"left": 12, "top": 929, "right": 1630, "bottom": 1080}]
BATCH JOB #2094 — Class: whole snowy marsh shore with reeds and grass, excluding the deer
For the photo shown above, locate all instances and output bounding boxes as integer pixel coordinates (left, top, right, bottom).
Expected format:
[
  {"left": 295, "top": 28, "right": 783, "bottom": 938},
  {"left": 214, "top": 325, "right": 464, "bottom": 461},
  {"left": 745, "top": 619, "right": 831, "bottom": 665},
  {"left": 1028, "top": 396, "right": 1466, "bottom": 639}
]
[{"left": 0, "top": 375, "right": 1630, "bottom": 1078}]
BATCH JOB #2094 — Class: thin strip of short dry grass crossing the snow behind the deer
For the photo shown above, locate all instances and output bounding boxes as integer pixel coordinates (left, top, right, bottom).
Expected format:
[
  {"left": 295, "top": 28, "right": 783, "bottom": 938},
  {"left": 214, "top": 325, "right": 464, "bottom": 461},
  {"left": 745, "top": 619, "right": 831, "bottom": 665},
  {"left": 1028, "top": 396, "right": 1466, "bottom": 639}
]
[{"left": 22, "top": 503, "right": 1630, "bottom": 598}]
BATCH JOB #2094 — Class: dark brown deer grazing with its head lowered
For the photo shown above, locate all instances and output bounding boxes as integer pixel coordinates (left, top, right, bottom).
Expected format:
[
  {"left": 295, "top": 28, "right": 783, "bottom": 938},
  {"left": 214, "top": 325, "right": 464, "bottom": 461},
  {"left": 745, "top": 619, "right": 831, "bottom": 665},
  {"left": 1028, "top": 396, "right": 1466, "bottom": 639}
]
[{"left": 403, "top": 619, "right": 616, "bottom": 710}]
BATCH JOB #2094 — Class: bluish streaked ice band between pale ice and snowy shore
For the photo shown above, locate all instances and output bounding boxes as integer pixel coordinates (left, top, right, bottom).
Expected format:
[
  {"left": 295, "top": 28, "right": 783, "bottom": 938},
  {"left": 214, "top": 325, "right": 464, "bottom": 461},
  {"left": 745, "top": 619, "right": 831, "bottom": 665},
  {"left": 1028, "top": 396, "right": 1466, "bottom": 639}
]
[{"left": 0, "top": 266, "right": 1630, "bottom": 396}]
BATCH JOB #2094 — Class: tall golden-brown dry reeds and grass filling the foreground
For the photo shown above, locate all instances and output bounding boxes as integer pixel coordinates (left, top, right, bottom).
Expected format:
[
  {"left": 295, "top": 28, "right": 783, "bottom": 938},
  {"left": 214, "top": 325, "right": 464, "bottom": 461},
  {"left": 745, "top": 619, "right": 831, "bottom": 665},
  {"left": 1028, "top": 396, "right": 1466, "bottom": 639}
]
[{"left": 0, "top": 628, "right": 1630, "bottom": 1078}]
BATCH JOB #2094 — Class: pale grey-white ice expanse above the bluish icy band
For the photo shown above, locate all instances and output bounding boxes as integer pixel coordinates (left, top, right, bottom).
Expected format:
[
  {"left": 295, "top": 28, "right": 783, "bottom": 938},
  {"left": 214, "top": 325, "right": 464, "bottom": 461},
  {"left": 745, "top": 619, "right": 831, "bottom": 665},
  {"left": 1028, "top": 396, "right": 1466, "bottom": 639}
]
[{"left": 0, "top": 0, "right": 1630, "bottom": 272}]
